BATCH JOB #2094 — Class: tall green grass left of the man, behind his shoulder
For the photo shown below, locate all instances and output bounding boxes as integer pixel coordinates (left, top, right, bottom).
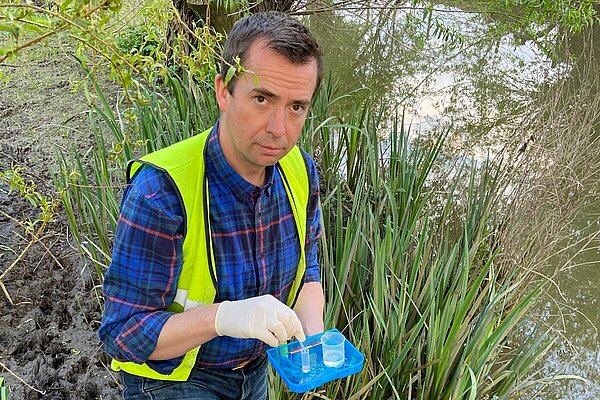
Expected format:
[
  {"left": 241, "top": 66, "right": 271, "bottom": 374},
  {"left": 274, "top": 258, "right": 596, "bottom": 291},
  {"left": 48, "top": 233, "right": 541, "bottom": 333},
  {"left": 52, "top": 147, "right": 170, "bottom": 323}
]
[{"left": 54, "top": 75, "right": 218, "bottom": 282}]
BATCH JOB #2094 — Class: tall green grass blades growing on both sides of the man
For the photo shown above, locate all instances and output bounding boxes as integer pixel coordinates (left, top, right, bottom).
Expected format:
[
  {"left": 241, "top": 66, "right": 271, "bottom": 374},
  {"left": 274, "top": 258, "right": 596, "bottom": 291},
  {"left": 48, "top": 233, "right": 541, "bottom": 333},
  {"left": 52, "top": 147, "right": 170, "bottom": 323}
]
[{"left": 57, "top": 73, "right": 548, "bottom": 400}]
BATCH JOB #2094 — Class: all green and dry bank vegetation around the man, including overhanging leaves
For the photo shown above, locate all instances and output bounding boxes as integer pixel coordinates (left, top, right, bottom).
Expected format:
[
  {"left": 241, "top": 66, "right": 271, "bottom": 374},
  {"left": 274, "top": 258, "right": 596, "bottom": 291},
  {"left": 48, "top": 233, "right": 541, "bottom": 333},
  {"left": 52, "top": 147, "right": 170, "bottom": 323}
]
[{"left": 0, "top": 1, "right": 600, "bottom": 399}]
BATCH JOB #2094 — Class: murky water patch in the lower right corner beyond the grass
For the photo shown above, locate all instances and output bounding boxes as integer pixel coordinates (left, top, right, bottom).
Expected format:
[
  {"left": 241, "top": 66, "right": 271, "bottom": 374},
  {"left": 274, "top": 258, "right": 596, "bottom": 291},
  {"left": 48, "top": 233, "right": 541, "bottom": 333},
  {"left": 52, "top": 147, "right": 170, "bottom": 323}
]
[{"left": 535, "top": 208, "right": 600, "bottom": 400}]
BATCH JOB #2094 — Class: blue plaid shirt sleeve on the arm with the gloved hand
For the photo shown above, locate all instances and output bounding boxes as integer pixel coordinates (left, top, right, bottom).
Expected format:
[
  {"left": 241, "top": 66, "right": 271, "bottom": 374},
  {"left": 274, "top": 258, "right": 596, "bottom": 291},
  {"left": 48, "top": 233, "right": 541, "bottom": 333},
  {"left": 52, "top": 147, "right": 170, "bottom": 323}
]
[{"left": 98, "top": 166, "right": 184, "bottom": 374}]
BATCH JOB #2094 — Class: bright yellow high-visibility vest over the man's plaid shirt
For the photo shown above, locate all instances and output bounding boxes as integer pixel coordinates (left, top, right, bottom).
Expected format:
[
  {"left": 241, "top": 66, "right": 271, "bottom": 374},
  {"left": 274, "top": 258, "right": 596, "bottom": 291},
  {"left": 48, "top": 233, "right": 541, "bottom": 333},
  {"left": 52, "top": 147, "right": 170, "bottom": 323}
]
[{"left": 111, "top": 129, "right": 310, "bottom": 381}]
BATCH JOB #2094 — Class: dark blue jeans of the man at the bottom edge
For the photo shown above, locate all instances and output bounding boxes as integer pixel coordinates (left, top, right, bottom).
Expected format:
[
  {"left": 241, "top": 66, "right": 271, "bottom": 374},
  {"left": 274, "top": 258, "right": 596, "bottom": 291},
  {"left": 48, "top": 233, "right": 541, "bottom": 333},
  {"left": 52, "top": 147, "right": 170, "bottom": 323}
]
[{"left": 121, "top": 357, "right": 267, "bottom": 400}]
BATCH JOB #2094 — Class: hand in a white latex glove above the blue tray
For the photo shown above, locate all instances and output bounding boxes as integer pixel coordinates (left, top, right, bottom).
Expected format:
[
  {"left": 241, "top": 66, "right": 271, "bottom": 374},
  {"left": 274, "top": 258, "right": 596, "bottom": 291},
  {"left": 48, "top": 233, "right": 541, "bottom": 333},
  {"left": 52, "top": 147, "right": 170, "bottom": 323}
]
[{"left": 215, "top": 294, "right": 306, "bottom": 347}]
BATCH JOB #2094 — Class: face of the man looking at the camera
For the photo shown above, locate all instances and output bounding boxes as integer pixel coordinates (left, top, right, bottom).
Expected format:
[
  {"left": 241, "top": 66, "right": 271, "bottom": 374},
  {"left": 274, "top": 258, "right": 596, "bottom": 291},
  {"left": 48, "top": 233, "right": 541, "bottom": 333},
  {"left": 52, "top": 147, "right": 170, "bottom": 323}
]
[{"left": 215, "top": 40, "right": 317, "bottom": 186}]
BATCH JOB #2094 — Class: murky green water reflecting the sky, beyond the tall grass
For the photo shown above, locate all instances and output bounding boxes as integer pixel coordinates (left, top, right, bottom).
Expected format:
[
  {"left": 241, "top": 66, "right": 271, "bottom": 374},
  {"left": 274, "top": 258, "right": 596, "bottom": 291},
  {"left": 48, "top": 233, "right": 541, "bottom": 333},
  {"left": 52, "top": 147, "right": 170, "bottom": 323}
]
[{"left": 310, "top": 5, "right": 600, "bottom": 400}]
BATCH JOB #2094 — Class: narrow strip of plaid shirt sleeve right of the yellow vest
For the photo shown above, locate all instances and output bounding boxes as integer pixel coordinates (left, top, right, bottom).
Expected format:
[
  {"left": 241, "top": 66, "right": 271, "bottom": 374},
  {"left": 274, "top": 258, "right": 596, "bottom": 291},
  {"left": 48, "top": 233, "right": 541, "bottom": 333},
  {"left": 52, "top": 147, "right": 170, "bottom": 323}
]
[{"left": 302, "top": 151, "right": 322, "bottom": 282}]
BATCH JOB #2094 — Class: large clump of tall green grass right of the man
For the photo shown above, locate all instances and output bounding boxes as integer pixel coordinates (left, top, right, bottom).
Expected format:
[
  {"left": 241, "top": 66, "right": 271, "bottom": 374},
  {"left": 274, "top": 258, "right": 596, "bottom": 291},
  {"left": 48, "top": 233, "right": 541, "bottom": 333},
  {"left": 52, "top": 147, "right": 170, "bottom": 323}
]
[{"left": 292, "top": 86, "right": 549, "bottom": 399}]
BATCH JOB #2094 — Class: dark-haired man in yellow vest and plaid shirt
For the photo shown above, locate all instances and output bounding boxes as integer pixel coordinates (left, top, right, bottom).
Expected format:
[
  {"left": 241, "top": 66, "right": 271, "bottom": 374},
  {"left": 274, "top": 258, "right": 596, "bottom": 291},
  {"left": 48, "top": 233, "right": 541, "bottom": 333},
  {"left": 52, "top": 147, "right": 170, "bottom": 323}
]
[{"left": 99, "top": 12, "right": 324, "bottom": 400}]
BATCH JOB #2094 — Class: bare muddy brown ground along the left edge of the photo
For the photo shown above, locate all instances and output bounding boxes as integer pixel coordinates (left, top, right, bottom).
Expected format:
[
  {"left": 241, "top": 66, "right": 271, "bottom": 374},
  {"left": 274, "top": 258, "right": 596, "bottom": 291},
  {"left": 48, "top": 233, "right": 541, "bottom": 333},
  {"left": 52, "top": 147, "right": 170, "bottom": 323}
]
[{"left": 0, "top": 36, "right": 119, "bottom": 400}]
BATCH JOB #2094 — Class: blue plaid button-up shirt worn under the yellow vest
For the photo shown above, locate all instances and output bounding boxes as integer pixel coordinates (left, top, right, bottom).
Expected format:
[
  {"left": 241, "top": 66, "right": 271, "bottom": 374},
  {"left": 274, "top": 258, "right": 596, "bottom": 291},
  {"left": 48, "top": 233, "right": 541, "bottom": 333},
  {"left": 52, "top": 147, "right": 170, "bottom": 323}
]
[{"left": 98, "top": 125, "right": 321, "bottom": 373}]
